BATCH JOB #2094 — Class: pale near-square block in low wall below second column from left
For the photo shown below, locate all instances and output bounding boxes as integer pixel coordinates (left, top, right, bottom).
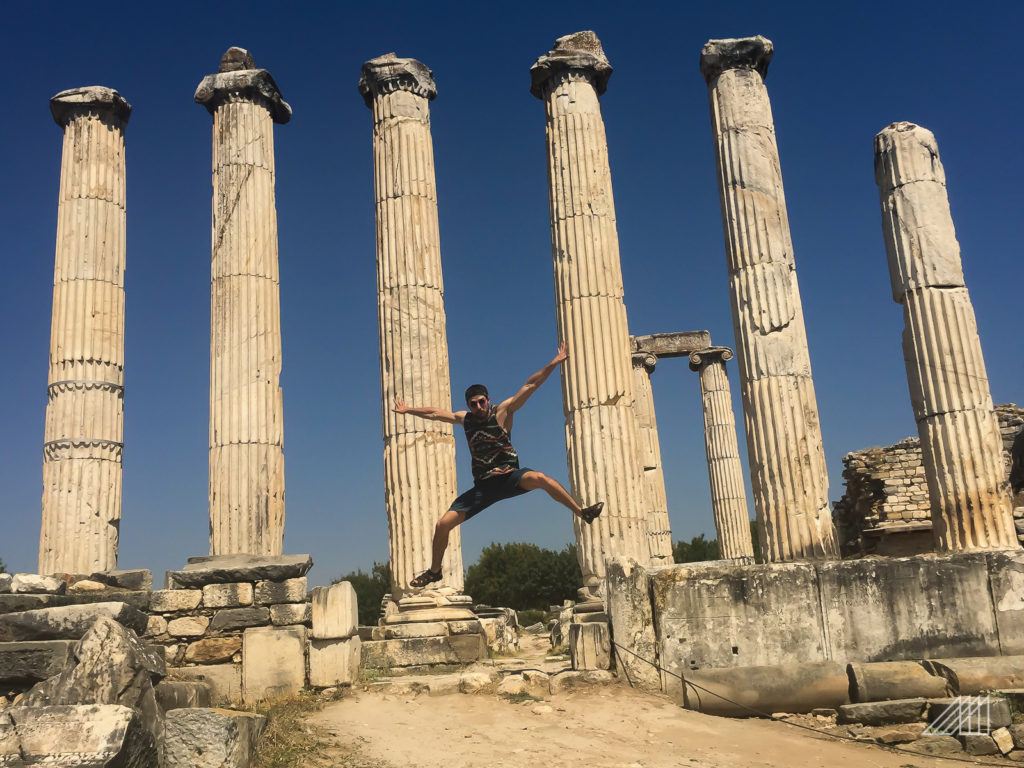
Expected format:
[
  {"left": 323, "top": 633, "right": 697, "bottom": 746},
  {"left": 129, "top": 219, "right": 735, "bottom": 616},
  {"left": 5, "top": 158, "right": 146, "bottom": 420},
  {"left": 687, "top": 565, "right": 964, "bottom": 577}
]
[{"left": 242, "top": 626, "right": 306, "bottom": 703}]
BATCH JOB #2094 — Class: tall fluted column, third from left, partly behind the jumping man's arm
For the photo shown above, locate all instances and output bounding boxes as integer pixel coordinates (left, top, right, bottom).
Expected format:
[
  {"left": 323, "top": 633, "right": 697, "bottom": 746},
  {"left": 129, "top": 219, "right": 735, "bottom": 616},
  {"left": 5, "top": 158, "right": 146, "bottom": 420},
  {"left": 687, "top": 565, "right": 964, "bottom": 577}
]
[{"left": 359, "top": 53, "right": 463, "bottom": 596}]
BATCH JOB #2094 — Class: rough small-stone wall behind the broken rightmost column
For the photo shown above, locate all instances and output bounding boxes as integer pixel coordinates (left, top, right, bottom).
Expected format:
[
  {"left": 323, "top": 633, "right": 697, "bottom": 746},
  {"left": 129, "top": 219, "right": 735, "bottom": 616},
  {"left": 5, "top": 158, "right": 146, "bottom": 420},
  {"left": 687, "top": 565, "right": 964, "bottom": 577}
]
[{"left": 833, "top": 403, "right": 1024, "bottom": 557}]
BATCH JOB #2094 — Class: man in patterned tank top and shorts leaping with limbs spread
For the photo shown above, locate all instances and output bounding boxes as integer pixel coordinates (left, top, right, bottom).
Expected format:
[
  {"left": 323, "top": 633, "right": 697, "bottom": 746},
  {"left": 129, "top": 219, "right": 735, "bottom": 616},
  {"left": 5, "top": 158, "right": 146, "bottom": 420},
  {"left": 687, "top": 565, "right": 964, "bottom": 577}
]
[{"left": 394, "top": 342, "right": 604, "bottom": 588}]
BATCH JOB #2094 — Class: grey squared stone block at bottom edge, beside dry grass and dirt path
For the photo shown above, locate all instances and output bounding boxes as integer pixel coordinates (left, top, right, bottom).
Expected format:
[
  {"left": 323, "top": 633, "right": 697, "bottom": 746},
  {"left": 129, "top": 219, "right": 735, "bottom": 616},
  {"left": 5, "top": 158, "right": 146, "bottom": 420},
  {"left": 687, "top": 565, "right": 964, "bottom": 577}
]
[{"left": 164, "top": 709, "right": 266, "bottom": 768}]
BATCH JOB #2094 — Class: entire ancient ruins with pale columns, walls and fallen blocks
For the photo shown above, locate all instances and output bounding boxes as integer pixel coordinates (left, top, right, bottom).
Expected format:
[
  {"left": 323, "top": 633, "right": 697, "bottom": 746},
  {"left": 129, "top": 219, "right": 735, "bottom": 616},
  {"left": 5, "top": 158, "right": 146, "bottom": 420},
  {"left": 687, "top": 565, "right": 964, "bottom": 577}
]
[{"left": 0, "top": 31, "right": 1024, "bottom": 768}]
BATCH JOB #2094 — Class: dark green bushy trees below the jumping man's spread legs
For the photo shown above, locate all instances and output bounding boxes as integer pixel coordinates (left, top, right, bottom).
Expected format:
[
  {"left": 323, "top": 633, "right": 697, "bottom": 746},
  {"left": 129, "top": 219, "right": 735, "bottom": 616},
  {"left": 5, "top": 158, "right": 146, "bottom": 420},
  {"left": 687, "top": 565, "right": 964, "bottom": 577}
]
[{"left": 466, "top": 542, "right": 583, "bottom": 610}]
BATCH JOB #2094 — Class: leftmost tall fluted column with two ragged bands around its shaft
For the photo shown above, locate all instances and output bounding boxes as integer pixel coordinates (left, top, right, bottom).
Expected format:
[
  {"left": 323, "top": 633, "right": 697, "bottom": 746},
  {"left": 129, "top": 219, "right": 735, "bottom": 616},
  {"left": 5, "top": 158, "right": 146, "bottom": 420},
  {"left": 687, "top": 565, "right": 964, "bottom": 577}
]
[{"left": 39, "top": 86, "right": 131, "bottom": 573}]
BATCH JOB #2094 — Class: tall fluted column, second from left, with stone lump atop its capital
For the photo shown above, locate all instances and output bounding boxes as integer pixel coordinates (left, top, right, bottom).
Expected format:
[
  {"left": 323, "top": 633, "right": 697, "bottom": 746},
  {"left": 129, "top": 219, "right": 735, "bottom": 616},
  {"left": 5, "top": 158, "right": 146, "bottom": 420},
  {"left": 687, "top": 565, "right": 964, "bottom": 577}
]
[{"left": 196, "top": 48, "right": 292, "bottom": 555}]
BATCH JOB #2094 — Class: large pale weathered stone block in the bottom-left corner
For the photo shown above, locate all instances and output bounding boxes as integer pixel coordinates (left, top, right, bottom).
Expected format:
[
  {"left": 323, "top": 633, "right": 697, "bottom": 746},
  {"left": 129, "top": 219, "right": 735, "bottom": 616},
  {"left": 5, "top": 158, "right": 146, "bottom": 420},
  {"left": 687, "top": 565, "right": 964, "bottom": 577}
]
[{"left": 0, "top": 705, "right": 158, "bottom": 768}]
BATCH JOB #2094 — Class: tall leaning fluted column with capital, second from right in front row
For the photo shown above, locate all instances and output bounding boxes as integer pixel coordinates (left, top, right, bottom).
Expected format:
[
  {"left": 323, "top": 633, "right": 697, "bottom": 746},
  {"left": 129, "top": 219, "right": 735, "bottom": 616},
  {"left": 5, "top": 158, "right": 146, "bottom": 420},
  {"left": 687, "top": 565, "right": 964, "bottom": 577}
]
[{"left": 700, "top": 37, "right": 839, "bottom": 562}]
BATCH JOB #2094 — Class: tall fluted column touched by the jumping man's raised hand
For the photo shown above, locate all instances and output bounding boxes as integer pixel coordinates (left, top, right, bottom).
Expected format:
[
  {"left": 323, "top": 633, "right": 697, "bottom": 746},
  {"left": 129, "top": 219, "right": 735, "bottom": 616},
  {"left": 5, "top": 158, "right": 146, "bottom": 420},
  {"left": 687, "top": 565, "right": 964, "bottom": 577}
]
[{"left": 530, "top": 32, "right": 650, "bottom": 596}]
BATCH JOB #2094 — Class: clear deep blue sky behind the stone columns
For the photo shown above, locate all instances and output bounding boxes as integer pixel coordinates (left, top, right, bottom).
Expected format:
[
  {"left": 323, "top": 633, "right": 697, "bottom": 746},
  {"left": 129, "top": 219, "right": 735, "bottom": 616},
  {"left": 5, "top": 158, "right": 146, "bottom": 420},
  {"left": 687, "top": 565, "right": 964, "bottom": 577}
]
[{"left": 0, "top": 0, "right": 1024, "bottom": 582}]
